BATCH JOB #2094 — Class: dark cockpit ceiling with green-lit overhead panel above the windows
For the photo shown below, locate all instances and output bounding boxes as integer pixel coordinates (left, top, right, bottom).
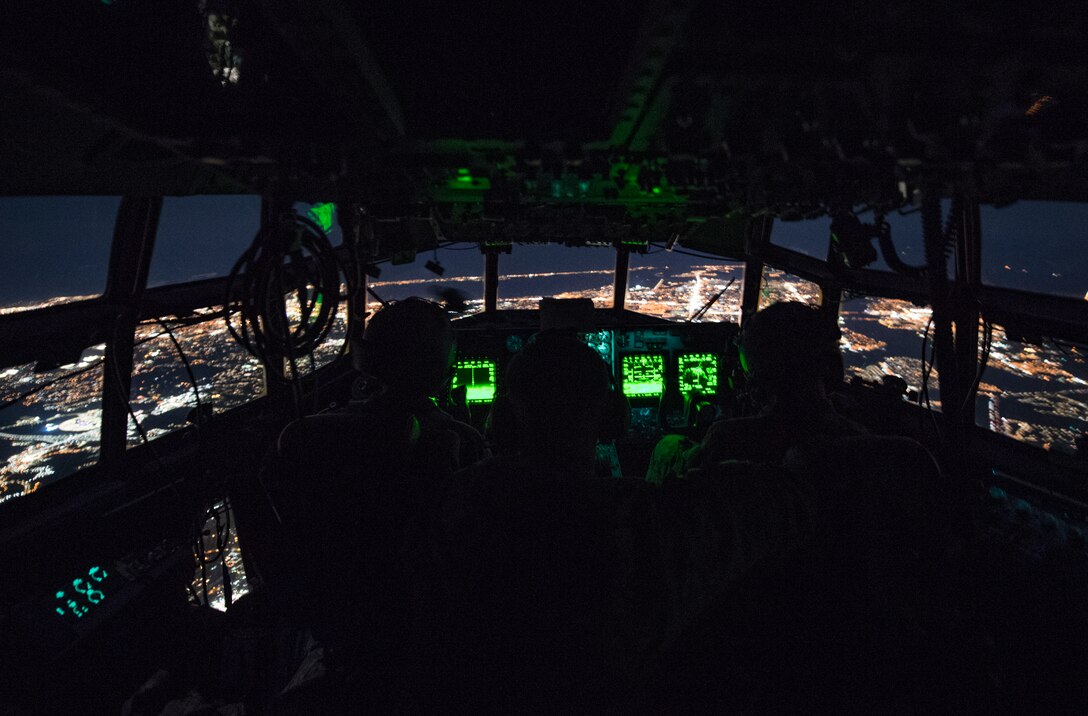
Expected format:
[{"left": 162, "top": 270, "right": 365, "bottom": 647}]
[{"left": 0, "top": 0, "right": 1088, "bottom": 219}]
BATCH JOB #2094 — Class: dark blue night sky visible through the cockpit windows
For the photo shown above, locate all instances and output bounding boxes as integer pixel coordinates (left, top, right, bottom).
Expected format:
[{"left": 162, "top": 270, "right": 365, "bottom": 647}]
[{"left": 0, "top": 196, "right": 1088, "bottom": 305}]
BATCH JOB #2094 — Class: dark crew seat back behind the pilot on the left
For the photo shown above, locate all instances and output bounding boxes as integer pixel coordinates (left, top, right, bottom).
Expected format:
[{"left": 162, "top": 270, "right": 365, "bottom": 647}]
[{"left": 263, "top": 411, "right": 449, "bottom": 692}]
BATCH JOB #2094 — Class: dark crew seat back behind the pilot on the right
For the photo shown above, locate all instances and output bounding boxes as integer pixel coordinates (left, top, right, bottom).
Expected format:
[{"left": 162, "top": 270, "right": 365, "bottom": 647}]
[{"left": 786, "top": 435, "right": 974, "bottom": 712}]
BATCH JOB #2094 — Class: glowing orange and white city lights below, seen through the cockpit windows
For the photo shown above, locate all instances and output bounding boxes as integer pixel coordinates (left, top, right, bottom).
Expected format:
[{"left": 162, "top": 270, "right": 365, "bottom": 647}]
[{"left": 0, "top": 270, "right": 1088, "bottom": 502}]
